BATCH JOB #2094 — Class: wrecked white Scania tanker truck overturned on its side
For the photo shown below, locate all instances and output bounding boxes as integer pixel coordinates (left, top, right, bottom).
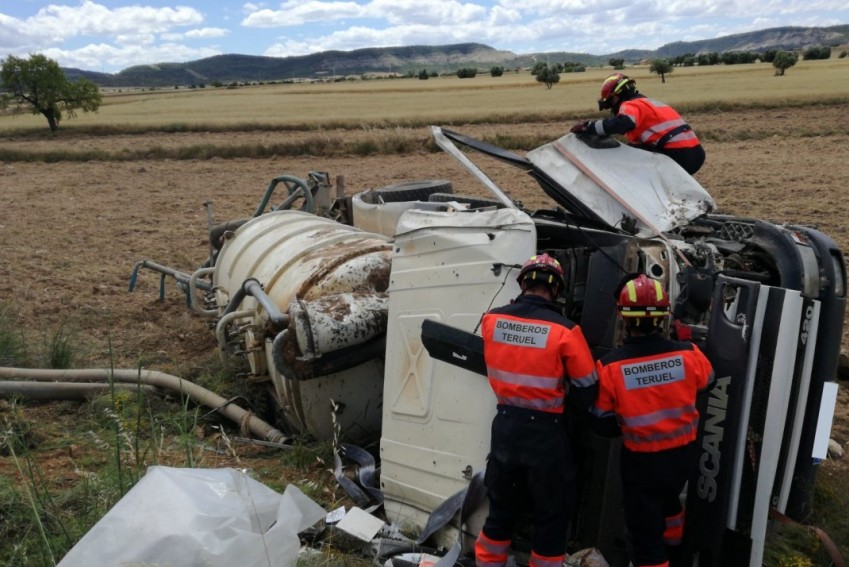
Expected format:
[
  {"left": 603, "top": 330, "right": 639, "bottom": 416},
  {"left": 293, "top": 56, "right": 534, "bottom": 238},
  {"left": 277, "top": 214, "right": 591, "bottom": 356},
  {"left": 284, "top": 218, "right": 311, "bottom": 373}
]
[{"left": 131, "top": 127, "right": 846, "bottom": 565}]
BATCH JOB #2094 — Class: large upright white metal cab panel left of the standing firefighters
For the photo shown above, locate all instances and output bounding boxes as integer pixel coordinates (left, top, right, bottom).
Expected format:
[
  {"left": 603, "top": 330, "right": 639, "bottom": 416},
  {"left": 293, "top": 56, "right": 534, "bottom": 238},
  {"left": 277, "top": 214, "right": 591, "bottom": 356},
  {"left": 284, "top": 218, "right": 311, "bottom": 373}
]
[{"left": 380, "top": 209, "right": 536, "bottom": 545}]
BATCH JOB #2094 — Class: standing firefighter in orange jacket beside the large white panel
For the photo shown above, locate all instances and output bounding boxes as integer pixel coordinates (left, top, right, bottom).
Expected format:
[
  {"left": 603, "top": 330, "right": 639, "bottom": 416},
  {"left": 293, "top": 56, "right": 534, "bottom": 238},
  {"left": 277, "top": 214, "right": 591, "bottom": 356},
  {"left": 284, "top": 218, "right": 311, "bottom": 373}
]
[{"left": 475, "top": 254, "right": 597, "bottom": 567}]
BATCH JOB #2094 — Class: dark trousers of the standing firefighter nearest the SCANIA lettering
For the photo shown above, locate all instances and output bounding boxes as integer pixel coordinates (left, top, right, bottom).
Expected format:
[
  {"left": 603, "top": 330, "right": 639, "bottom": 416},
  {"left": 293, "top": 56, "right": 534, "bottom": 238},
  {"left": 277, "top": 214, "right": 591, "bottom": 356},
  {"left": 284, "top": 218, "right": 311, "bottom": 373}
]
[{"left": 621, "top": 443, "right": 697, "bottom": 566}]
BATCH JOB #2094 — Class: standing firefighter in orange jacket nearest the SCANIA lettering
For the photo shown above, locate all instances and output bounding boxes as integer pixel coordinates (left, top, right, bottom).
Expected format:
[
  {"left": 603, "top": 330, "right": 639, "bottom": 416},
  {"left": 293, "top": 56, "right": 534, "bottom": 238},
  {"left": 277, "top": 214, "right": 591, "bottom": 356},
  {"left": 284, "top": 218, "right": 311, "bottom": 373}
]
[{"left": 591, "top": 274, "right": 713, "bottom": 567}]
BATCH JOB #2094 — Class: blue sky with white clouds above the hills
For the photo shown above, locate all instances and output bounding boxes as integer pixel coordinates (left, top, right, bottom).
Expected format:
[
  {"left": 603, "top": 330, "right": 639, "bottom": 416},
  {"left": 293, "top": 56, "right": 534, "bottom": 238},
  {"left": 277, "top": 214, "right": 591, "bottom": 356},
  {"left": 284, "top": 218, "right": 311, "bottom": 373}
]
[{"left": 0, "top": 0, "right": 849, "bottom": 73}]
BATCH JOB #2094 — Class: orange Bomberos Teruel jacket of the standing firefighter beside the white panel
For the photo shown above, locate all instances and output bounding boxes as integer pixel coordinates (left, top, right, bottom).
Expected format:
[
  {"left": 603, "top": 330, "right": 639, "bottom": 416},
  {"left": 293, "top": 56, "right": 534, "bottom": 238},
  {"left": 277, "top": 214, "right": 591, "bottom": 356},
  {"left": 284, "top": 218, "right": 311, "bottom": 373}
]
[{"left": 481, "top": 295, "right": 597, "bottom": 413}]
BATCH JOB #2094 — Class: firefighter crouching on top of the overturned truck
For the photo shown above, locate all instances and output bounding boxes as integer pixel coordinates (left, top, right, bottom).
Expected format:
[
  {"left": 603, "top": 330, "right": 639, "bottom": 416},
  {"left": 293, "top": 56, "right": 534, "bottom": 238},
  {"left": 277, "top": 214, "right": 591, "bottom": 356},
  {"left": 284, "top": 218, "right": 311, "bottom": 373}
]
[{"left": 570, "top": 73, "right": 705, "bottom": 175}]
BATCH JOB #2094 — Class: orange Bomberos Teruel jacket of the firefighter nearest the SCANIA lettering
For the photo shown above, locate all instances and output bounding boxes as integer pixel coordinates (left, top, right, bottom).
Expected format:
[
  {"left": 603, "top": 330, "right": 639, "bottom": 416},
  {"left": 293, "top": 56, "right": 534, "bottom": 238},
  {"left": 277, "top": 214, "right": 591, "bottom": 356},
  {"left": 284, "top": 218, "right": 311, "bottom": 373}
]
[{"left": 591, "top": 336, "right": 713, "bottom": 452}]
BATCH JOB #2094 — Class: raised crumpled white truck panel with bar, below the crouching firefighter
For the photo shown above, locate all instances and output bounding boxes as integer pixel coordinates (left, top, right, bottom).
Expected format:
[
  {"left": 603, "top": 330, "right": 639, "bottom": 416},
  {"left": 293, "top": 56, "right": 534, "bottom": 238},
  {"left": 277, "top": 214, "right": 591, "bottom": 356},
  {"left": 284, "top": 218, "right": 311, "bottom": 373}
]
[{"left": 433, "top": 126, "right": 716, "bottom": 237}]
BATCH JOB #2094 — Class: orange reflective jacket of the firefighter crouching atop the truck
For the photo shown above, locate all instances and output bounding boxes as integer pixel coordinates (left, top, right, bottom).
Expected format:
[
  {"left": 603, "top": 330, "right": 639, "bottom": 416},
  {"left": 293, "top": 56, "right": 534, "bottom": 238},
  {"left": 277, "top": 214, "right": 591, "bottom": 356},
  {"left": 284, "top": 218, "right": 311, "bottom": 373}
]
[{"left": 596, "top": 94, "right": 700, "bottom": 150}]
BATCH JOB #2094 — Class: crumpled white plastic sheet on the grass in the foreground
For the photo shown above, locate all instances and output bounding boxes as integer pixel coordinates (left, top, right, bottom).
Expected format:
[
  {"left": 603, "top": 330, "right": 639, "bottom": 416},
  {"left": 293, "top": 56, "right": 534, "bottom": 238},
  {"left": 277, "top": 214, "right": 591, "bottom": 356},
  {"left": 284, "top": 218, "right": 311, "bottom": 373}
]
[{"left": 59, "top": 467, "right": 327, "bottom": 567}]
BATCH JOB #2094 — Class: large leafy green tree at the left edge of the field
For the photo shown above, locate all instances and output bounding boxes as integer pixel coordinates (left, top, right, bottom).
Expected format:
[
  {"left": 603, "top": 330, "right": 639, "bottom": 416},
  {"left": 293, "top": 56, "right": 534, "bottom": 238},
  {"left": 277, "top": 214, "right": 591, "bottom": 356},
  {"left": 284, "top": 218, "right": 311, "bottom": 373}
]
[{"left": 0, "top": 53, "right": 102, "bottom": 132}]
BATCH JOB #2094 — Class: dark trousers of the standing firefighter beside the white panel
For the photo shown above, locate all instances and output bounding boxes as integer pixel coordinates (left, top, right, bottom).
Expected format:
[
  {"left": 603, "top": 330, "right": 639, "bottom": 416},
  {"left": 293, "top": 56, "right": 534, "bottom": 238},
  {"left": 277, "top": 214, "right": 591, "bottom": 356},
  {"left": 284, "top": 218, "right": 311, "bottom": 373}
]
[{"left": 476, "top": 411, "right": 575, "bottom": 557}]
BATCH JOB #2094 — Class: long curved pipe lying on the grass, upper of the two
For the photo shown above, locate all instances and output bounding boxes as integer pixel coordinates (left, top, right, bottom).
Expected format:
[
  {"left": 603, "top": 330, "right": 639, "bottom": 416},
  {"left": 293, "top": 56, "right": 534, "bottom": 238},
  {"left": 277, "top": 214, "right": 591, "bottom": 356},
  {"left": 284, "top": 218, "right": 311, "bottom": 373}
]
[{"left": 0, "top": 367, "right": 286, "bottom": 443}]
